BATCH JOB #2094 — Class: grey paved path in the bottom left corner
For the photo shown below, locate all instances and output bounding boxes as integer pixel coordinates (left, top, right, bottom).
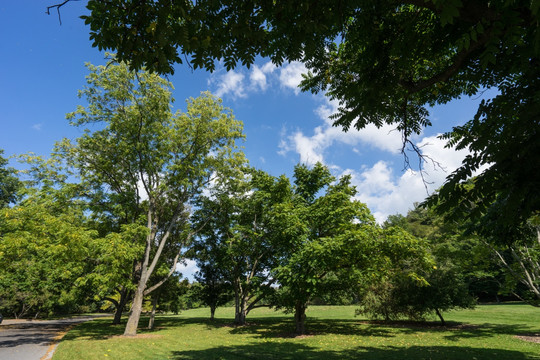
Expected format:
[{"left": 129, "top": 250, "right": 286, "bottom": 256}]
[{"left": 0, "top": 316, "right": 106, "bottom": 360}]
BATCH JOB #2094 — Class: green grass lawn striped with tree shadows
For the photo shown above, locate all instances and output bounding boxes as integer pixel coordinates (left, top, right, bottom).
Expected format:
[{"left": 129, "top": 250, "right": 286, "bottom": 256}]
[{"left": 53, "top": 304, "right": 540, "bottom": 360}]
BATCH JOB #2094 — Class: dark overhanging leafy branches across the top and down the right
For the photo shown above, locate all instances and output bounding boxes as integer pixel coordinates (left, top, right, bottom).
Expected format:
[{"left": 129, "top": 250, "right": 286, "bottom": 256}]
[{"left": 77, "top": 0, "right": 540, "bottom": 240}]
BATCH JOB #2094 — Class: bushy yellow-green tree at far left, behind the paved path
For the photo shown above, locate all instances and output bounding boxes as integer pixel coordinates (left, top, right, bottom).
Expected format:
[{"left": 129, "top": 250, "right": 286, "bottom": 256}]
[{"left": 0, "top": 157, "right": 97, "bottom": 318}]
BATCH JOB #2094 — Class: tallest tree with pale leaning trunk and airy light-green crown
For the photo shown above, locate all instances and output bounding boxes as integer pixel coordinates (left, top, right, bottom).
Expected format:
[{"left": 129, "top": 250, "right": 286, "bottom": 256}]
[{"left": 63, "top": 62, "right": 242, "bottom": 335}]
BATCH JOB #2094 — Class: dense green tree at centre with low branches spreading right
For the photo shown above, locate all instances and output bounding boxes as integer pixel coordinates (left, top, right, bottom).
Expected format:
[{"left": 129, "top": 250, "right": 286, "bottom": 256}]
[{"left": 272, "top": 164, "right": 429, "bottom": 334}]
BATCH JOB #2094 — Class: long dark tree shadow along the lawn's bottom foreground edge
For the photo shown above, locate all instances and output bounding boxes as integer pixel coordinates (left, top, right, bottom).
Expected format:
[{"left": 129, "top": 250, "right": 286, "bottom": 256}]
[{"left": 171, "top": 343, "right": 536, "bottom": 360}]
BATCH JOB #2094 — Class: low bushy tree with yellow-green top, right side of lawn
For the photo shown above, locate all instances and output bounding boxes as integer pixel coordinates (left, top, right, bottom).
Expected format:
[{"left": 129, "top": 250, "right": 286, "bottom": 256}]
[{"left": 357, "top": 227, "right": 475, "bottom": 325}]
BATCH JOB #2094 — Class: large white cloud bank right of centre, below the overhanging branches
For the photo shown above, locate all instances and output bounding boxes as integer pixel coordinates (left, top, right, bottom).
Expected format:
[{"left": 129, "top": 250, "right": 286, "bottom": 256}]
[{"left": 279, "top": 97, "right": 476, "bottom": 222}]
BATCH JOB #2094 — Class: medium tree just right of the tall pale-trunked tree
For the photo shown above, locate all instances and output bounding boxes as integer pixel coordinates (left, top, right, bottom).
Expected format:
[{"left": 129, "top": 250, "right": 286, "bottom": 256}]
[{"left": 193, "top": 169, "right": 291, "bottom": 325}]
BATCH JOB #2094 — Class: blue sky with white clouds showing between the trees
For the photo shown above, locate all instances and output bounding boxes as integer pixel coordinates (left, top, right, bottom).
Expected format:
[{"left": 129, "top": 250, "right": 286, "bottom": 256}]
[{"left": 0, "top": 0, "right": 496, "bottom": 278}]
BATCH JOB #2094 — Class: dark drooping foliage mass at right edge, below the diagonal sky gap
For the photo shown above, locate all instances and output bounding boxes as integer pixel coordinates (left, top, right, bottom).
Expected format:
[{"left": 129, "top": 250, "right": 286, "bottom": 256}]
[{"left": 427, "top": 66, "right": 540, "bottom": 244}]
